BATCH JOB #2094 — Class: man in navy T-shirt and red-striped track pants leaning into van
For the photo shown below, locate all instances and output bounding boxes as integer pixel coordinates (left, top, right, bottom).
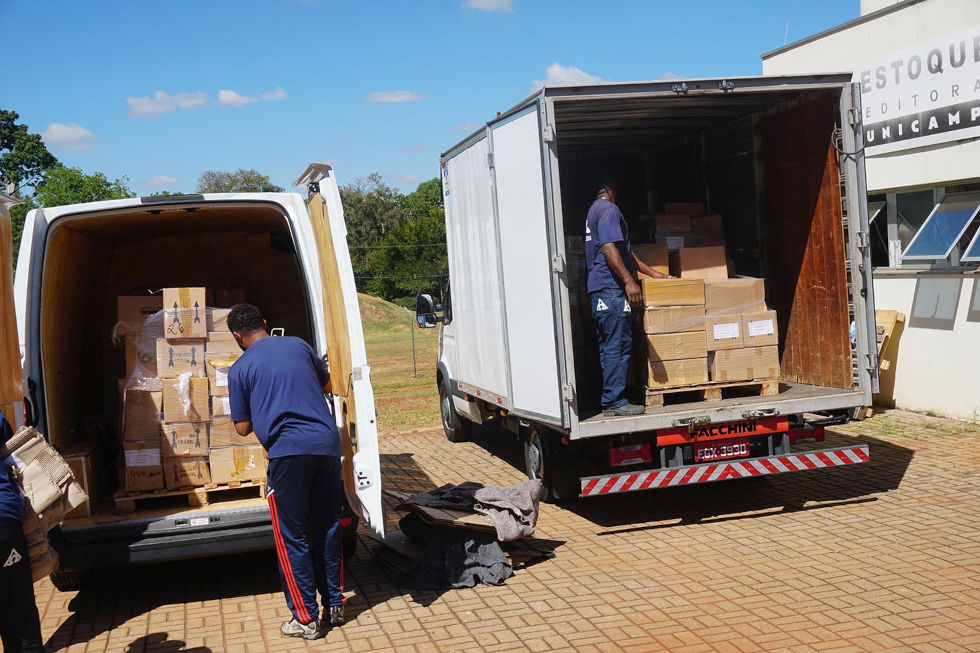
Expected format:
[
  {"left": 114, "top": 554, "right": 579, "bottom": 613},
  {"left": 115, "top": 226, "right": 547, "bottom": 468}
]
[{"left": 228, "top": 304, "right": 344, "bottom": 639}]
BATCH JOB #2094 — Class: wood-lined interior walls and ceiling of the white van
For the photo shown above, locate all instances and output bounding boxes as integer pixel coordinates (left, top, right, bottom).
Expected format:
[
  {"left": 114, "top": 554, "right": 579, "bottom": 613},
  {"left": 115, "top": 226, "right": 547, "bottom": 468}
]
[{"left": 40, "top": 203, "right": 312, "bottom": 449}]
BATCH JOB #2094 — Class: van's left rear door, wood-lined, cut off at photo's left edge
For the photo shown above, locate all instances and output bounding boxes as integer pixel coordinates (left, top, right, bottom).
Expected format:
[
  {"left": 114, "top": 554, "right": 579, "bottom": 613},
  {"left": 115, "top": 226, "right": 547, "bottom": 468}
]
[{"left": 0, "top": 193, "right": 24, "bottom": 430}]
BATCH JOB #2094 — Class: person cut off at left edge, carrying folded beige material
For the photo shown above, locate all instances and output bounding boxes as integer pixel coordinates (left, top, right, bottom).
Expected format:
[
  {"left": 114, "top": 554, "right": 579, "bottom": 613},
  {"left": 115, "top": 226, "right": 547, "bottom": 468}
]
[{"left": 0, "top": 414, "right": 44, "bottom": 653}]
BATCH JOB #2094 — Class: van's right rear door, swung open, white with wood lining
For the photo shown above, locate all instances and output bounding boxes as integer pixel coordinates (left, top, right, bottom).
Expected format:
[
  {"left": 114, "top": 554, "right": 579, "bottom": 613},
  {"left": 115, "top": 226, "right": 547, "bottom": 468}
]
[{"left": 296, "top": 163, "right": 385, "bottom": 535}]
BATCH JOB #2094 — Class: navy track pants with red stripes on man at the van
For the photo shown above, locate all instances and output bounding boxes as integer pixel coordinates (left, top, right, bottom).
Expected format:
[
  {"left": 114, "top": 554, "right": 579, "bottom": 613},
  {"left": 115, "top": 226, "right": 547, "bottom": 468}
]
[{"left": 266, "top": 456, "right": 344, "bottom": 624}]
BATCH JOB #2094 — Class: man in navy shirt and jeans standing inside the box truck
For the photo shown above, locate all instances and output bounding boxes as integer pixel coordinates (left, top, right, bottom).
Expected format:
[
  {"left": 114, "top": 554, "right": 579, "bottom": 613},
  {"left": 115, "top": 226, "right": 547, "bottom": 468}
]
[{"left": 585, "top": 175, "right": 665, "bottom": 416}]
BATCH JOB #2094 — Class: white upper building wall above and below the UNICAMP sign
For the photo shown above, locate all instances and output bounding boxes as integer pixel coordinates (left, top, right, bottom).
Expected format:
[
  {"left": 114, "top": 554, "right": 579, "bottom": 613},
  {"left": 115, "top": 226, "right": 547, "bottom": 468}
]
[{"left": 762, "top": 0, "right": 980, "bottom": 193}]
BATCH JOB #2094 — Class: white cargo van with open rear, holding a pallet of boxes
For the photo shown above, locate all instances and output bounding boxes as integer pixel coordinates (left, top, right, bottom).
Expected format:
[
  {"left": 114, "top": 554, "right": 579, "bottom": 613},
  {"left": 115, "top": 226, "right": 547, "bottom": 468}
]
[{"left": 14, "top": 164, "right": 384, "bottom": 587}]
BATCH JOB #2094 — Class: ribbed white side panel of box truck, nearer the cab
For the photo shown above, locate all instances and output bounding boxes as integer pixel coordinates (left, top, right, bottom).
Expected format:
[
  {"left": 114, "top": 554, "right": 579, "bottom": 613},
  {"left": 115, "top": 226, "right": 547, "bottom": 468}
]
[{"left": 443, "top": 138, "right": 510, "bottom": 400}]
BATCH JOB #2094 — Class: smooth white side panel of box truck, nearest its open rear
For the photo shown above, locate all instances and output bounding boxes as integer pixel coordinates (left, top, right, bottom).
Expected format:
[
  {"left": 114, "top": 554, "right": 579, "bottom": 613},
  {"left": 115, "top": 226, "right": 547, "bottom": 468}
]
[{"left": 491, "top": 104, "right": 562, "bottom": 424}]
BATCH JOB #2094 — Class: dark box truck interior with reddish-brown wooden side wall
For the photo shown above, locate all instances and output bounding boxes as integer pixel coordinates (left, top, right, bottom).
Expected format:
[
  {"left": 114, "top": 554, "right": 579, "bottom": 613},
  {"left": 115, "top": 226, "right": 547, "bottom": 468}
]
[{"left": 554, "top": 89, "right": 855, "bottom": 389}]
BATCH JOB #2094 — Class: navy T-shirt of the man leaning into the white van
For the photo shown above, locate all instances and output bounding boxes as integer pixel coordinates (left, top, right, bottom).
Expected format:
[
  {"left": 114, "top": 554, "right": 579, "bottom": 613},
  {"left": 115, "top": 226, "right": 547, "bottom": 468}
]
[{"left": 228, "top": 336, "right": 340, "bottom": 458}]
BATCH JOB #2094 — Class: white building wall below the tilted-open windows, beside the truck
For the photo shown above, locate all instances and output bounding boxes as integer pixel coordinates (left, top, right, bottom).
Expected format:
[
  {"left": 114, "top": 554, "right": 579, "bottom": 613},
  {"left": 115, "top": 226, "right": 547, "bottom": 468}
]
[{"left": 874, "top": 271, "right": 980, "bottom": 420}]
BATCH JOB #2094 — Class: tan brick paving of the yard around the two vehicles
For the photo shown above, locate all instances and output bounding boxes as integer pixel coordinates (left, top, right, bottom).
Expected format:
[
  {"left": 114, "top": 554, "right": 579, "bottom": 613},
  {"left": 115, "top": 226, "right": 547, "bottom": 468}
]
[{"left": 36, "top": 411, "right": 980, "bottom": 653}]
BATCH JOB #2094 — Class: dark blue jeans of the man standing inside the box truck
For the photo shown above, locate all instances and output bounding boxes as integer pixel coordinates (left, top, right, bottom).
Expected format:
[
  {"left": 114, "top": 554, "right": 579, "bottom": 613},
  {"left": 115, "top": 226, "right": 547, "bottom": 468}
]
[{"left": 589, "top": 288, "right": 633, "bottom": 409}]
